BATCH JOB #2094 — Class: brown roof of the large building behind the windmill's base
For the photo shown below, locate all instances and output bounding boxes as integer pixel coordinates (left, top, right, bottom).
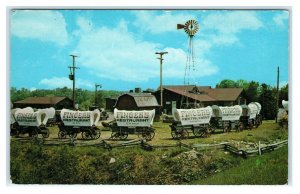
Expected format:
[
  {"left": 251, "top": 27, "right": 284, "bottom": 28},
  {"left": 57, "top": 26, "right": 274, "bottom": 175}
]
[{"left": 164, "top": 85, "right": 243, "bottom": 102}]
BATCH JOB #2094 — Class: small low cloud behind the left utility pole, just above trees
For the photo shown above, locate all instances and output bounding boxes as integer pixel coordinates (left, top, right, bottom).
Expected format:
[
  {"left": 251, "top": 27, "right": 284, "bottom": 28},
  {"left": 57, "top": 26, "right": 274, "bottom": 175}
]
[{"left": 39, "top": 77, "right": 94, "bottom": 88}]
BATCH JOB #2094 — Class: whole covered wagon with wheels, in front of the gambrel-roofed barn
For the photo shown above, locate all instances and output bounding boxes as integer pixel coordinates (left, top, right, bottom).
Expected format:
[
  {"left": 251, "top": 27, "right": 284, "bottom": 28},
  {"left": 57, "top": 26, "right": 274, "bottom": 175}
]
[{"left": 104, "top": 108, "right": 155, "bottom": 141}]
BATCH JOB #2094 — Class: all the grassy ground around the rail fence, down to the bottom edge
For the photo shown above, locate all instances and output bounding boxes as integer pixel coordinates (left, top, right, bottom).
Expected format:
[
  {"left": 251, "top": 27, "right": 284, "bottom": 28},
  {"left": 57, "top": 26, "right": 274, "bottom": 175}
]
[{"left": 10, "top": 121, "right": 288, "bottom": 185}]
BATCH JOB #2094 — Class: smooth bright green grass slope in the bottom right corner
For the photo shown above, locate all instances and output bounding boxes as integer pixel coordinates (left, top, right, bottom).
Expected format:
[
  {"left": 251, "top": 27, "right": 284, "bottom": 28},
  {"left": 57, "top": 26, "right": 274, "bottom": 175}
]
[{"left": 191, "top": 146, "right": 288, "bottom": 185}]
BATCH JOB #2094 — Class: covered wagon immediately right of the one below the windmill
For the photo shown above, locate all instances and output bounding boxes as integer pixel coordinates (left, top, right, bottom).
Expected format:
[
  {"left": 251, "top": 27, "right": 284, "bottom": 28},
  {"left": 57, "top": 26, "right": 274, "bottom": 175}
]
[{"left": 210, "top": 105, "right": 244, "bottom": 132}]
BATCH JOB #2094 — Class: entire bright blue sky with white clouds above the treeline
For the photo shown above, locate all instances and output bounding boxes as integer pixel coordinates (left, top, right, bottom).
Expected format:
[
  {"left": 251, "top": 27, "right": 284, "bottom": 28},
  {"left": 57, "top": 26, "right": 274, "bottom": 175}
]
[{"left": 9, "top": 10, "right": 290, "bottom": 91}]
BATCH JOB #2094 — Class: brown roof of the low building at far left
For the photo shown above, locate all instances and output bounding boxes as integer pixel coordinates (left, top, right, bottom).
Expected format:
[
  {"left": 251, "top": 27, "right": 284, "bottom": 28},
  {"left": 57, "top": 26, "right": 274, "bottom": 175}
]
[{"left": 14, "top": 96, "right": 72, "bottom": 105}]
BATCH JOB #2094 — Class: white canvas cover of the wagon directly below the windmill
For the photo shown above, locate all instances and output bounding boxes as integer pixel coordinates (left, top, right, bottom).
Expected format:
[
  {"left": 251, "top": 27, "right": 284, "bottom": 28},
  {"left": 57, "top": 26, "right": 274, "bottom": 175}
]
[{"left": 173, "top": 106, "right": 212, "bottom": 125}]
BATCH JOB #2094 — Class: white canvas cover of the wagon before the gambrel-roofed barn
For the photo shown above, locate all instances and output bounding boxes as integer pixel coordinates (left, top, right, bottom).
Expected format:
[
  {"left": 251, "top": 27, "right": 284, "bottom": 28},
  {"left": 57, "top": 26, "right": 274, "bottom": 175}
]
[{"left": 114, "top": 108, "right": 155, "bottom": 127}]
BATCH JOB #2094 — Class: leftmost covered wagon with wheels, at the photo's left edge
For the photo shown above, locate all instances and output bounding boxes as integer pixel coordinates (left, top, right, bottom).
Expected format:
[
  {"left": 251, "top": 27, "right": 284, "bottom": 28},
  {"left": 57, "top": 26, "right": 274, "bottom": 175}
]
[{"left": 11, "top": 107, "right": 49, "bottom": 138}]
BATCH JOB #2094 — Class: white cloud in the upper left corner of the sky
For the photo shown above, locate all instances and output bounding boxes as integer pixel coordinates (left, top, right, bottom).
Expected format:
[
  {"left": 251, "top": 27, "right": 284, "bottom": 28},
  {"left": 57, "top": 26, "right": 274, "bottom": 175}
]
[{"left": 11, "top": 10, "right": 68, "bottom": 46}]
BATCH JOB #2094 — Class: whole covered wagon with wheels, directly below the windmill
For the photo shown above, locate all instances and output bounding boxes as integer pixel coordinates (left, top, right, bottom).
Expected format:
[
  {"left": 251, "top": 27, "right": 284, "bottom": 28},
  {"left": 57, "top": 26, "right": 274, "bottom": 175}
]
[{"left": 170, "top": 106, "right": 212, "bottom": 139}]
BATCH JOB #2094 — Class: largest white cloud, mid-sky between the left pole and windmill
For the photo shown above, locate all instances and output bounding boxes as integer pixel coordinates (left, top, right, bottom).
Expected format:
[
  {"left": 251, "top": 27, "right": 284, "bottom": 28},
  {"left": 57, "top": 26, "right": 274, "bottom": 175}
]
[{"left": 74, "top": 18, "right": 216, "bottom": 82}]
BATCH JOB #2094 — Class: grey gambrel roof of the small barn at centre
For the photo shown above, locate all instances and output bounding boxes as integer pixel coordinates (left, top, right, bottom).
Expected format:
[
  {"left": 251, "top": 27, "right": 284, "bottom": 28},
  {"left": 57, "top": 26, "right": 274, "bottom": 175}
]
[{"left": 119, "top": 93, "right": 159, "bottom": 107}]
